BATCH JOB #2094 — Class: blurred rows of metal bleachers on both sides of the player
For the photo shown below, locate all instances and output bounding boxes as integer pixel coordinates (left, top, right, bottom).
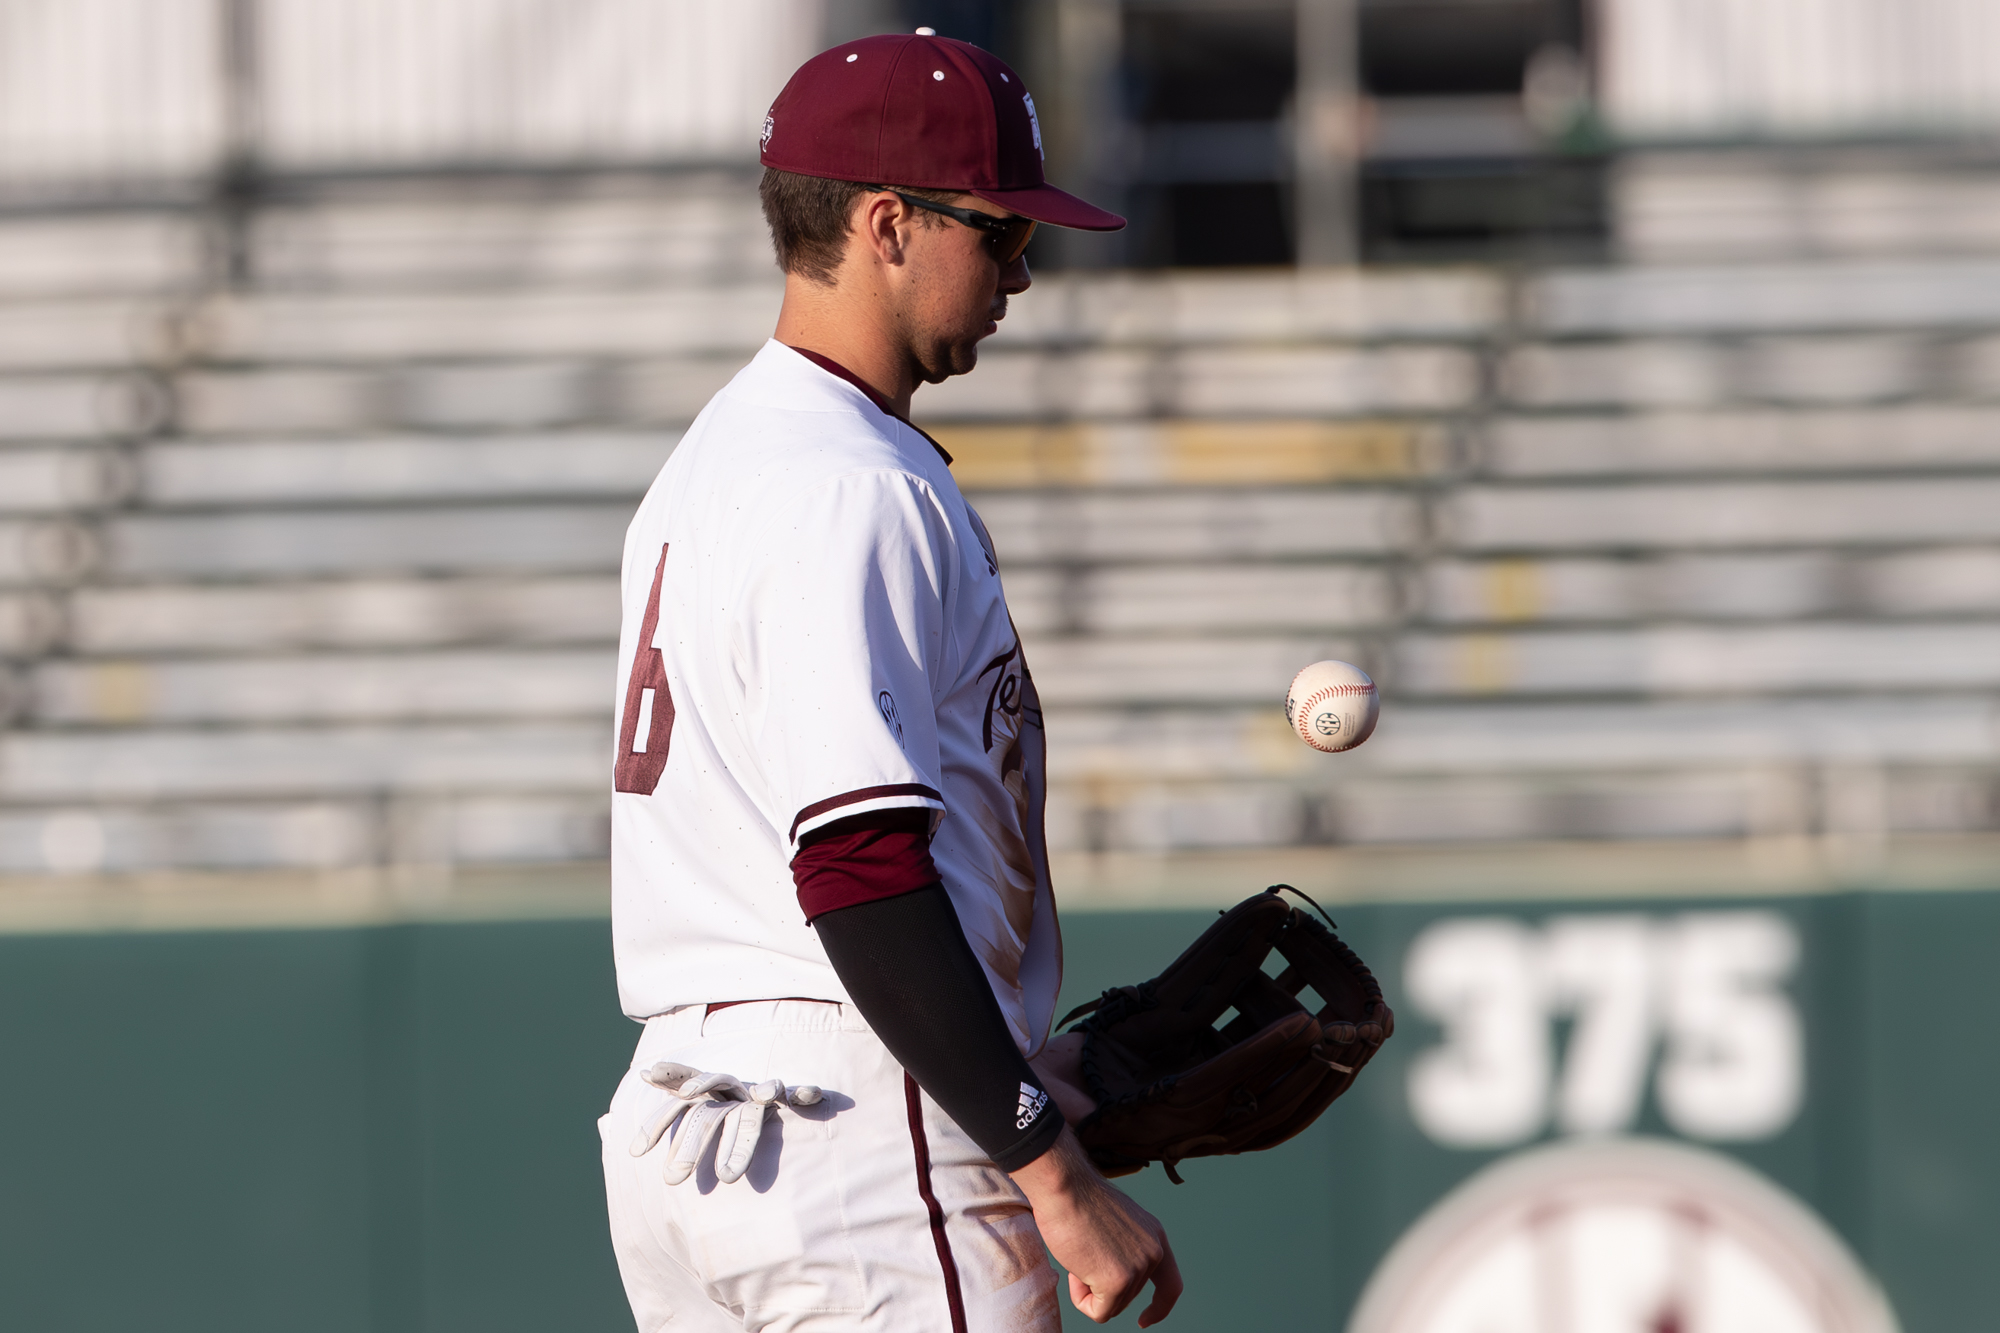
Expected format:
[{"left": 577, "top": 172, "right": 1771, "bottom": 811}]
[{"left": 11, "top": 172, "right": 2000, "bottom": 892}]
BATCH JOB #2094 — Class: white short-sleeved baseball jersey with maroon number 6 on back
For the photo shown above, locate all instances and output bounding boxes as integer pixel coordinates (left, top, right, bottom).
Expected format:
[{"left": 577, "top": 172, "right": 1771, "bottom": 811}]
[{"left": 612, "top": 342, "right": 1062, "bottom": 1055}]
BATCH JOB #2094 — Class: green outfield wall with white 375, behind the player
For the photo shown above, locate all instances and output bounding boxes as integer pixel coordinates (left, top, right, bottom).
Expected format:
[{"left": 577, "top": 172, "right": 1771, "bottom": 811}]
[{"left": 0, "top": 891, "right": 2000, "bottom": 1333}]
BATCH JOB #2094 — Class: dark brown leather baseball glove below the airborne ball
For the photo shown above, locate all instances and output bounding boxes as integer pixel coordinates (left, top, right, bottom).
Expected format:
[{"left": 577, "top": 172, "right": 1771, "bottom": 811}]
[{"left": 1062, "top": 885, "right": 1396, "bottom": 1185}]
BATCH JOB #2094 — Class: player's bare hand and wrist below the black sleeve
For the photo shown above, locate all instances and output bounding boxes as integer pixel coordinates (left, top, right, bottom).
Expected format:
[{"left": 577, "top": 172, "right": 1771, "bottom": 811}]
[{"left": 1014, "top": 1127, "right": 1180, "bottom": 1329}]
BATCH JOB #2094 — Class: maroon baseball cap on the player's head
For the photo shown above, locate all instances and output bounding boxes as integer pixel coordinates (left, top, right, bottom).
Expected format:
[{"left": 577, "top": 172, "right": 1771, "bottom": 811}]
[{"left": 762, "top": 34, "right": 1124, "bottom": 232}]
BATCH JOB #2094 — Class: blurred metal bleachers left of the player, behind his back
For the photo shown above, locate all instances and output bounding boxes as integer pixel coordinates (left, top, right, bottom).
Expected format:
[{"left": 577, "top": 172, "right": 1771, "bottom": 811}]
[{"left": 0, "top": 176, "right": 776, "bottom": 871}]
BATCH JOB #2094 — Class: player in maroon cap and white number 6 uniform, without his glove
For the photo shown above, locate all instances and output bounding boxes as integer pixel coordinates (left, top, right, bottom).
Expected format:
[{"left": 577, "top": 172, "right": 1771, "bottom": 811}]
[{"left": 600, "top": 34, "right": 1180, "bottom": 1333}]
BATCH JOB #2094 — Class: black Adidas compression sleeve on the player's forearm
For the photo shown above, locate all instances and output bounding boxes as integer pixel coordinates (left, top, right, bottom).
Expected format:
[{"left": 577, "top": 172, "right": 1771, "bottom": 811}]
[{"left": 812, "top": 885, "right": 1062, "bottom": 1171}]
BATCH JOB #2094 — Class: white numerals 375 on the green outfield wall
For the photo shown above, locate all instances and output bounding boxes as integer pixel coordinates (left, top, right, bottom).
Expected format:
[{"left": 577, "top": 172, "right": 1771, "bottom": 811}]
[{"left": 1402, "top": 911, "right": 1806, "bottom": 1149}]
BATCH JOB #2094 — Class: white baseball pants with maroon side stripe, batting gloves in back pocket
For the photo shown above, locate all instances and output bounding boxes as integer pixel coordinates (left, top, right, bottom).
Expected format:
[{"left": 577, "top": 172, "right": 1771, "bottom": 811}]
[{"left": 598, "top": 1001, "right": 1060, "bottom": 1333}]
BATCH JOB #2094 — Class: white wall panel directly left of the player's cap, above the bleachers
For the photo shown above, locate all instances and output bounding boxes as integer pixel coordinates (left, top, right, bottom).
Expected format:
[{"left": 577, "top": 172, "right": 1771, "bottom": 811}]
[{"left": 262, "top": 0, "right": 820, "bottom": 166}]
